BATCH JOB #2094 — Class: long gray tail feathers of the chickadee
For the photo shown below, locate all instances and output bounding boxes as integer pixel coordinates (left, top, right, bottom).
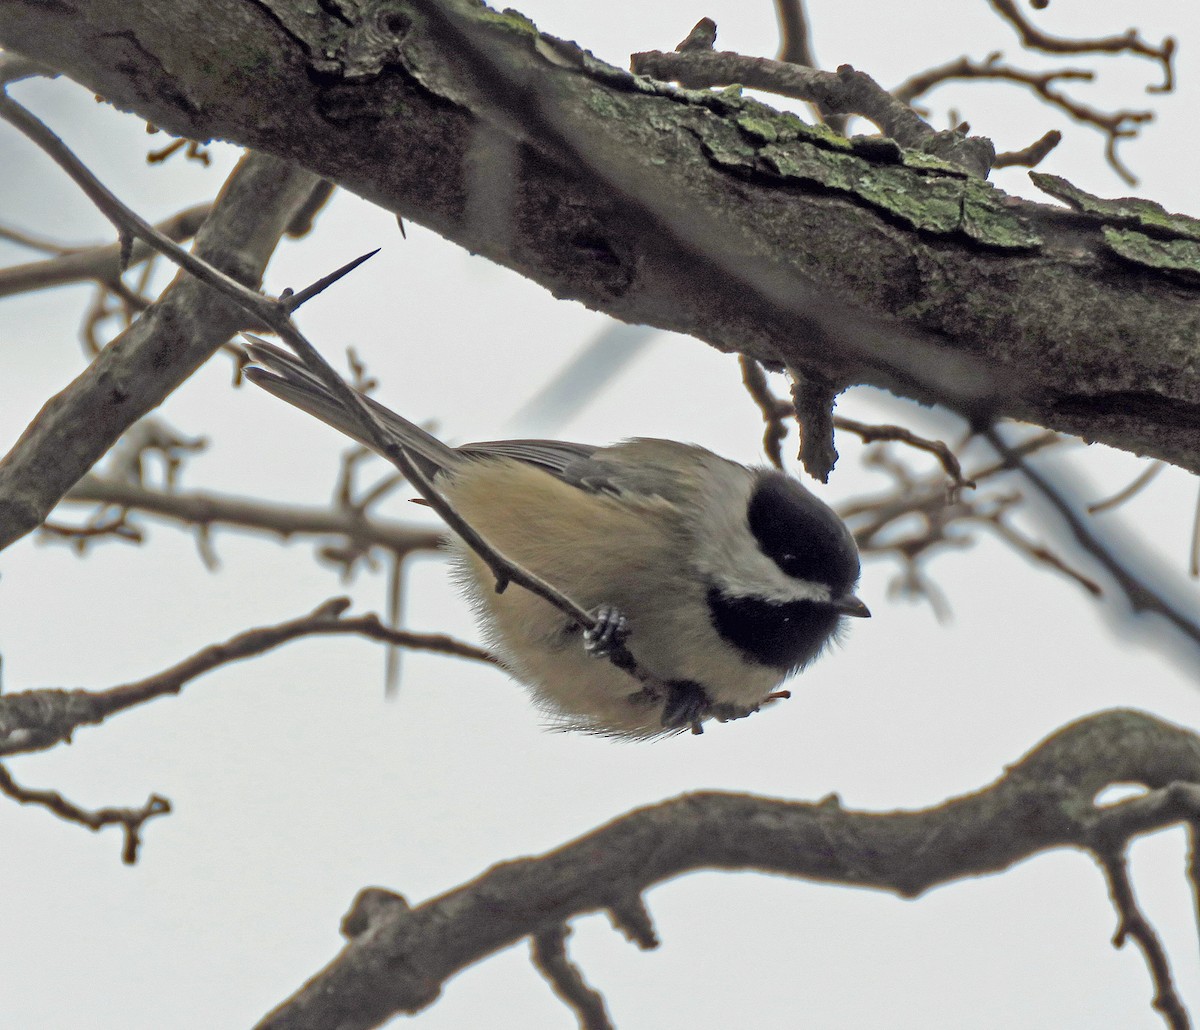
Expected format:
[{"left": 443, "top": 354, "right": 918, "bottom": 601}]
[{"left": 245, "top": 340, "right": 462, "bottom": 474}]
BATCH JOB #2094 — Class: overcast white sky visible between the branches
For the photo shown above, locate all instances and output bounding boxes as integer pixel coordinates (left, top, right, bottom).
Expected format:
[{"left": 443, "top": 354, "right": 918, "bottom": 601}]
[{"left": 0, "top": 0, "right": 1200, "bottom": 1030}]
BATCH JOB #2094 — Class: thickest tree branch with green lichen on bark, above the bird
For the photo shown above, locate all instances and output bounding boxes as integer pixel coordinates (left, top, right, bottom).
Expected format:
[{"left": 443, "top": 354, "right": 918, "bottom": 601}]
[{"left": 0, "top": 0, "right": 1200, "bottom": 471}]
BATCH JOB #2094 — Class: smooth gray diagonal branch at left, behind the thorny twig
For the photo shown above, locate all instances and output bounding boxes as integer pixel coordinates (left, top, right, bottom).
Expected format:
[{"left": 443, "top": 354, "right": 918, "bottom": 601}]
[{"left": 0, "top": 147, "right": 317, "bottom": 549}]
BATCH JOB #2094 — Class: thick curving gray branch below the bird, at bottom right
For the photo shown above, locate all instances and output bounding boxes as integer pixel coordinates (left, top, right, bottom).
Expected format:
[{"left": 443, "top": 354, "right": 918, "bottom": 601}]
[{"left": 259, "top": 709, "right": 1200, "bottom": 1030}]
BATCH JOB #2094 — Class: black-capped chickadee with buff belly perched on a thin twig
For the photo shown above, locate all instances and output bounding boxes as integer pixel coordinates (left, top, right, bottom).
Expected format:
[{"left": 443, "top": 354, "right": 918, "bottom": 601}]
[{"left": 246, "top": 342, "right": 870, "bottom": 738}]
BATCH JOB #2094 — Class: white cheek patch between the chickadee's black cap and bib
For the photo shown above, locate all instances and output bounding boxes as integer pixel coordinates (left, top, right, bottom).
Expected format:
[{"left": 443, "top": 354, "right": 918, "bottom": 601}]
[{"left": 695, "top": 455, "right": 832, "bottom": 604}]
